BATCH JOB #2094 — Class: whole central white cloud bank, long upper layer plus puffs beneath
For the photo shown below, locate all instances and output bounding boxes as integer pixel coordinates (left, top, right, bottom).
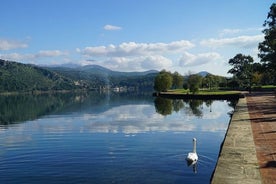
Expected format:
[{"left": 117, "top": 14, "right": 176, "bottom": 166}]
[{"left": 76, "top": 40, "right": 194, "bottom": 71}]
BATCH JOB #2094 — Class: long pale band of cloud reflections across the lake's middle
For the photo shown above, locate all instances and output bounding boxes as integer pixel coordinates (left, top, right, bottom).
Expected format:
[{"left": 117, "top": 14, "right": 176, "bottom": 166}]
[{"left": 1, "top": 102, "right": 231, "bottom": 136}]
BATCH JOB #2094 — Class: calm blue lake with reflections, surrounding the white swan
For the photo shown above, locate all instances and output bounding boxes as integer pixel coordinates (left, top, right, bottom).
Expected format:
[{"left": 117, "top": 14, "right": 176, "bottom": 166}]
[{"left": 0, "top": 93, "right": 235, "bottom": 184}]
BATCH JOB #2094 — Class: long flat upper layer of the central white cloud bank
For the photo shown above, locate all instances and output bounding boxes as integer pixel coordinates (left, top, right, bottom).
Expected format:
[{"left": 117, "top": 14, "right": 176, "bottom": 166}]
[{"left": 78, "top": 40, "right": 194, "bottom": 57}]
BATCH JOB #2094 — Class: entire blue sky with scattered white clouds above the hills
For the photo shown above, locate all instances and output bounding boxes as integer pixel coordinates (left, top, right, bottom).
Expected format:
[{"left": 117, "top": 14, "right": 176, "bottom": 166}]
[{"left": 0, "top": 0, "right": 274, "bottom": 76}]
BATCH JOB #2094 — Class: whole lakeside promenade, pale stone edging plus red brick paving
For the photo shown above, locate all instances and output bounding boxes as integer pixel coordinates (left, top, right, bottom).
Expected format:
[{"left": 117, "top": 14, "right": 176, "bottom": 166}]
[{"left": 211, "top": 93, "right": 276, "bottom": 184}]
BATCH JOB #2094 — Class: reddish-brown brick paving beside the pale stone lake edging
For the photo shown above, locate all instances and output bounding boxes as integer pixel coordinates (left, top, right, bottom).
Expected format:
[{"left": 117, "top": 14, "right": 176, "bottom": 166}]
[{"left": 246, "top": 93, "right": 276, "bottom": 184}]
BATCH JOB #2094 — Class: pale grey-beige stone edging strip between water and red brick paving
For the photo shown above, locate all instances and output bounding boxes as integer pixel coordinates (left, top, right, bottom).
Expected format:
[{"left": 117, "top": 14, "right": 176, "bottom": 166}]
[{"left": 211, "top": 98, "right": 262, "bottom": 184}]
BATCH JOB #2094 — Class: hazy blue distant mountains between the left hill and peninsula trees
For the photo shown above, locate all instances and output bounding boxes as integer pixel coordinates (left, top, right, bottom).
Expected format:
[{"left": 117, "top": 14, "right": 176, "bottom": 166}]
[{"left": 47, "top": 65, "right": 158, "bottom": 90}]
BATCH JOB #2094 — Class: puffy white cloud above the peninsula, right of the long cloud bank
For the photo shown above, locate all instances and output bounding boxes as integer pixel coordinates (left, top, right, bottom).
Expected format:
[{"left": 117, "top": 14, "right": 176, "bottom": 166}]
[{"left": 179, "top": 52, "right": 221, "bottom": 66}]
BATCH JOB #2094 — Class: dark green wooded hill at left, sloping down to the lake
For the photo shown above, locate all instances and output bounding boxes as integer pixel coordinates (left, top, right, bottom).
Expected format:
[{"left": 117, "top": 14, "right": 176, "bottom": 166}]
[{"left": 0, "top": 59, "right": 80, "bottom": 92}]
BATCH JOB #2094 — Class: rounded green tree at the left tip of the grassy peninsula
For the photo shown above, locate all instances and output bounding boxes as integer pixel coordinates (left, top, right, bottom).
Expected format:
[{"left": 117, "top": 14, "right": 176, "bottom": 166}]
[{"left": 154, "top": 70, "right": 173, "bottom": 92}]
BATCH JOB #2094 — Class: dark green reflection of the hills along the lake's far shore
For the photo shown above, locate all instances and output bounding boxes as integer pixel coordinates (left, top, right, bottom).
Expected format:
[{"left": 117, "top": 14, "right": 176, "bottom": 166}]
[{"left": 0, "top": 93, "right": 152, "bottom": 125}]
